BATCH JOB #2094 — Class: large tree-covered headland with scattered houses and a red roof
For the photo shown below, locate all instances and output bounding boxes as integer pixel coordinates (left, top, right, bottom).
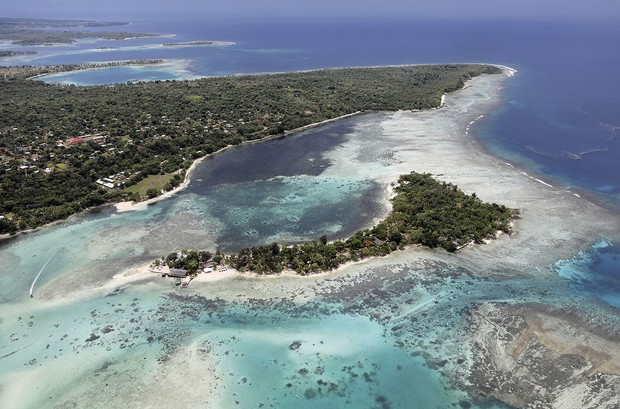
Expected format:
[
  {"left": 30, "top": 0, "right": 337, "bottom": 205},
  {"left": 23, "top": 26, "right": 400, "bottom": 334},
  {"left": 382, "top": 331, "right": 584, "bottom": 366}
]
[{"left": 0, "top": 61, "right": 501, "bottom": 232}]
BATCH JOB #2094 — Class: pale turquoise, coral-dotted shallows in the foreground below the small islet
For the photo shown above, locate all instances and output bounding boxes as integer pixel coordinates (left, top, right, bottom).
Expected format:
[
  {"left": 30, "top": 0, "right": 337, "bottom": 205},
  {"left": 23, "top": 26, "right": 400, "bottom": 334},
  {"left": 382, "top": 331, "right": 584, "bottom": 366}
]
[{"left": 0, "top": 256, "right": 540, "bottom": 408}]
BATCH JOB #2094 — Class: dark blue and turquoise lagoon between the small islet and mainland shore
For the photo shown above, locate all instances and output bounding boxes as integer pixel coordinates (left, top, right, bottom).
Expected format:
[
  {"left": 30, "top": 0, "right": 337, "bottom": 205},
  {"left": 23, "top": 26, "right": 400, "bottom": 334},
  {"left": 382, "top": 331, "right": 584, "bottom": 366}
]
[{"left": 183, "top": 114, "right": 387, "bottom": 250}]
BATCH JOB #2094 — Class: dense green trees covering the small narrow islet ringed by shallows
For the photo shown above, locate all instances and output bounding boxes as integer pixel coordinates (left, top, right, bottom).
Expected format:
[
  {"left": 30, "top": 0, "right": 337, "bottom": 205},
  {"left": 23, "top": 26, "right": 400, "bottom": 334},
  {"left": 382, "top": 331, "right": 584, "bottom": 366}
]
[{"left": 165, "top": 172, "right": 515, "bottom": 275}]
